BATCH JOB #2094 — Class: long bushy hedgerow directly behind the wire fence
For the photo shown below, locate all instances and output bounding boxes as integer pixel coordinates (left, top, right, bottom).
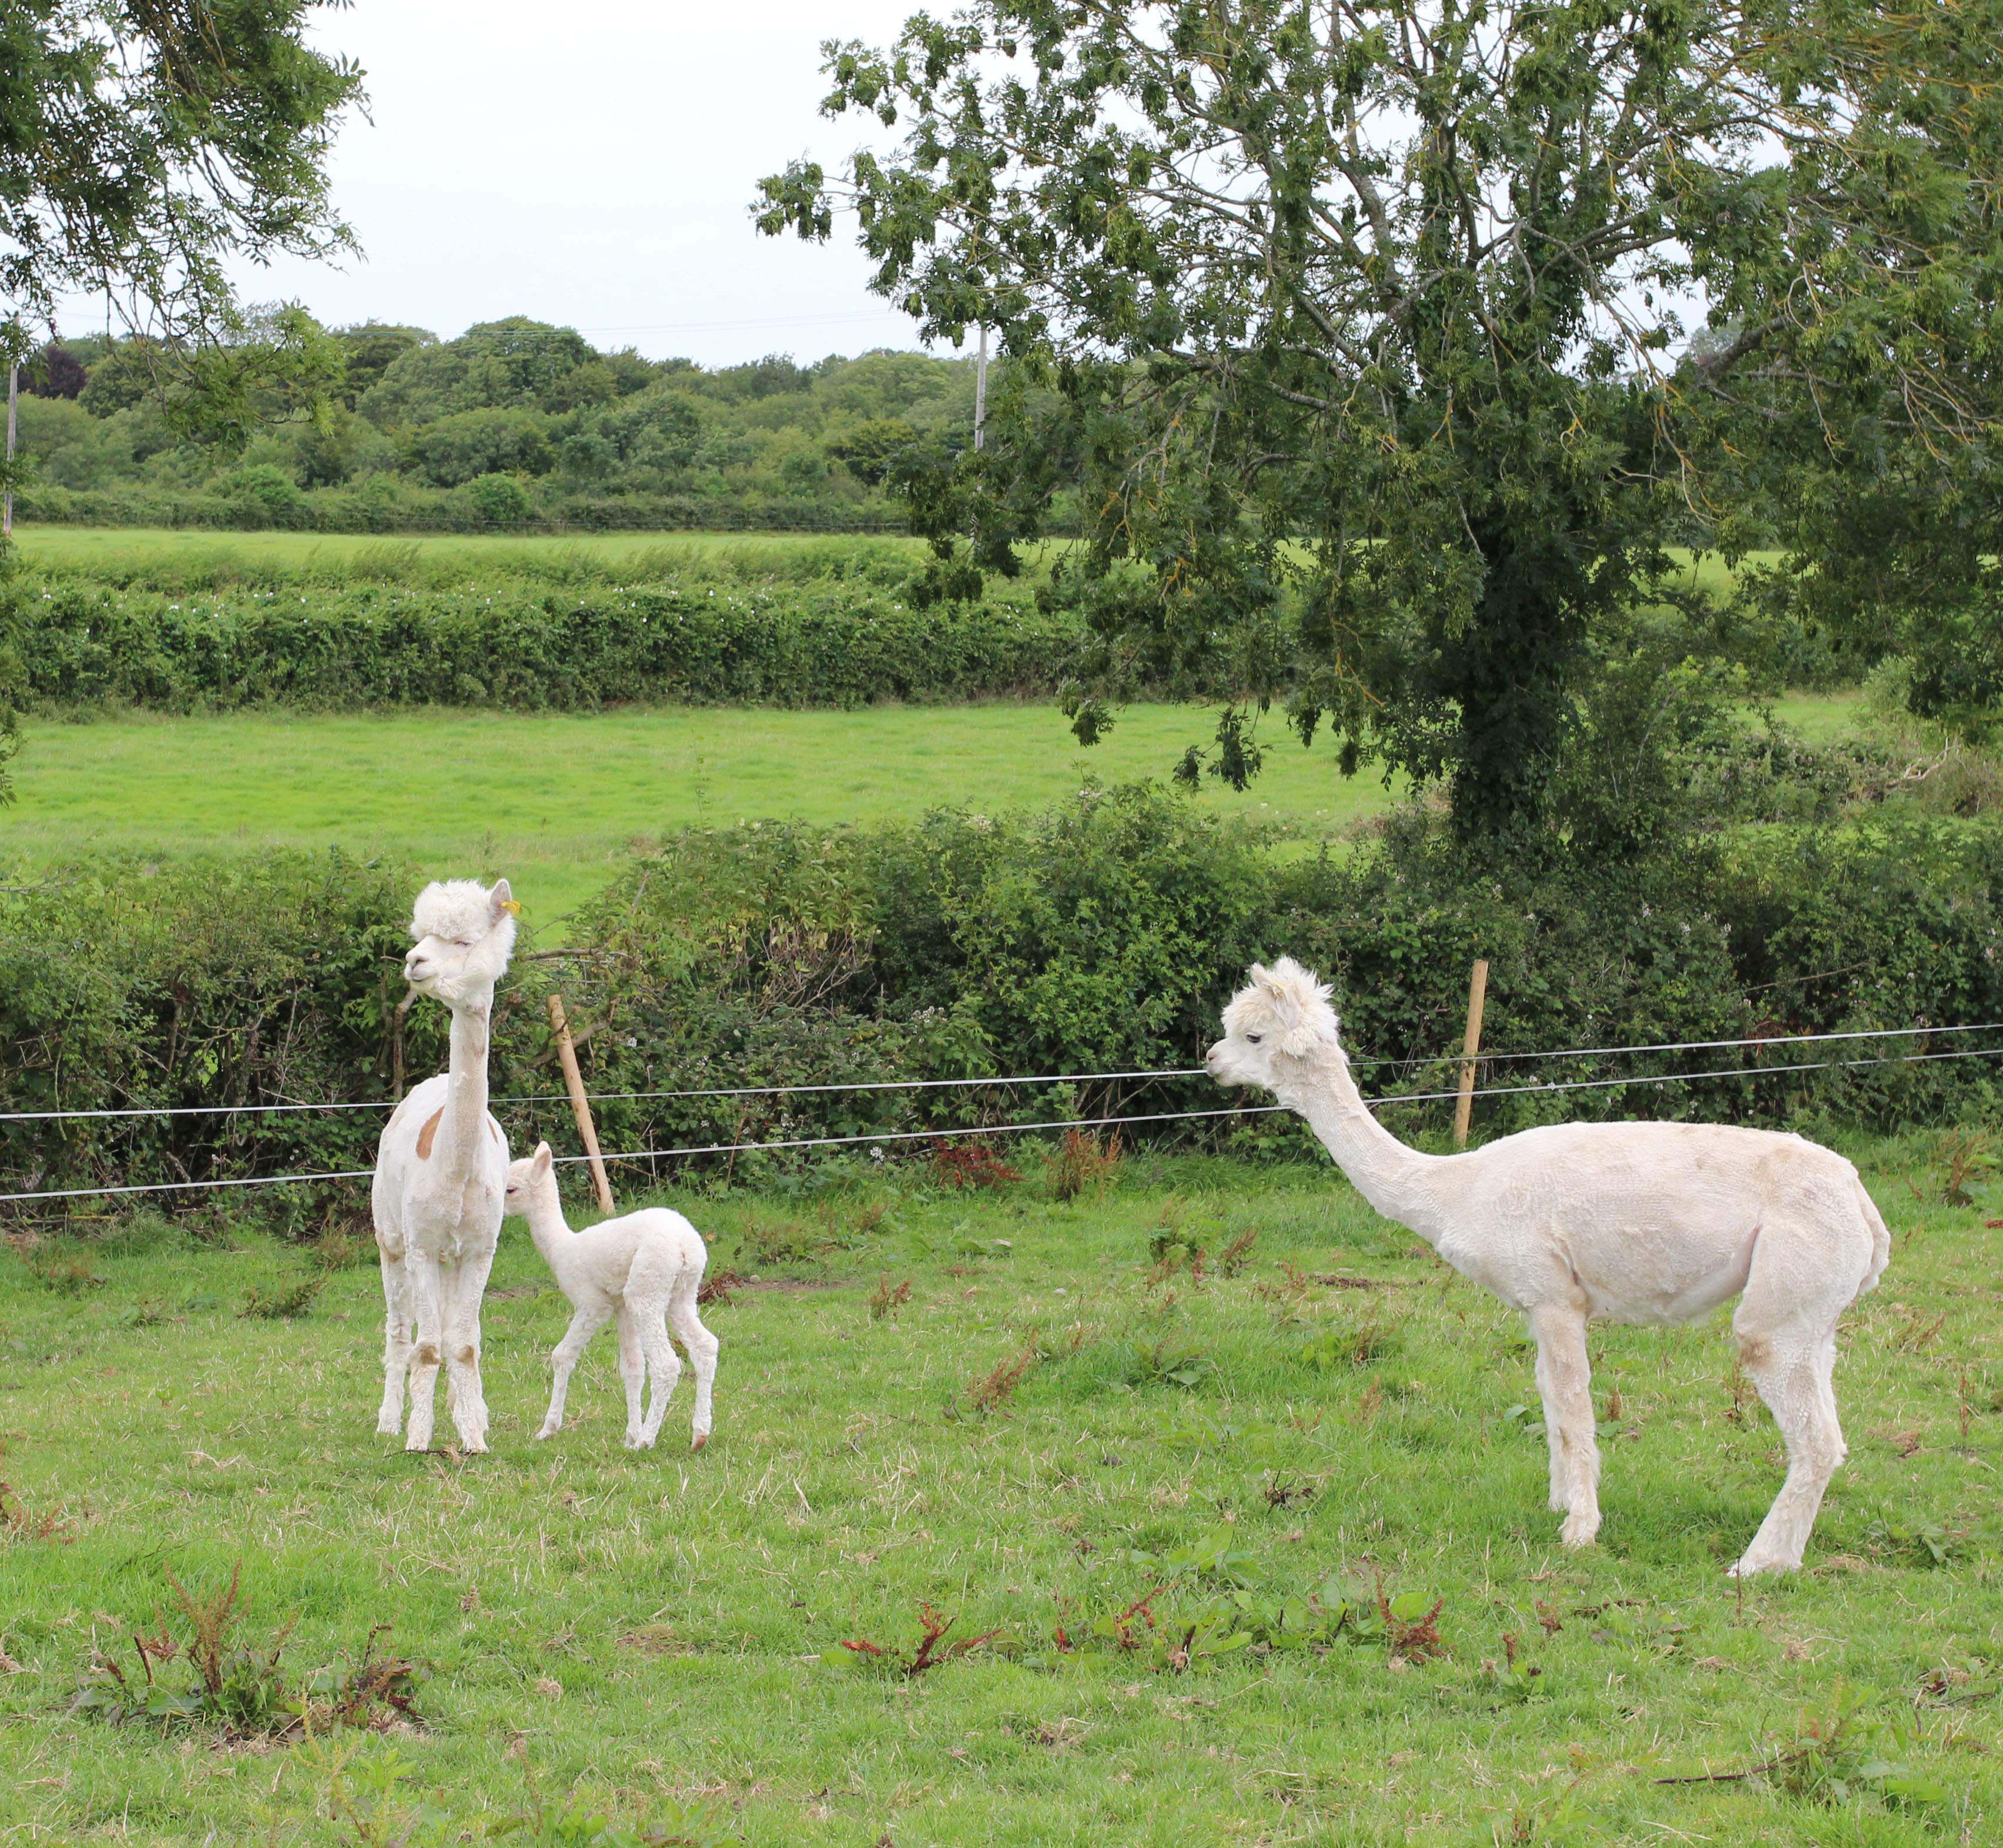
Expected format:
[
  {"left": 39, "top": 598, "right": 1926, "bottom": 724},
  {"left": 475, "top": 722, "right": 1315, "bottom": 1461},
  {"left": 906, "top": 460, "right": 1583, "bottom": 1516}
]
[{"left": 0, "top": 787, "right": 2003, "bottom": 1227}]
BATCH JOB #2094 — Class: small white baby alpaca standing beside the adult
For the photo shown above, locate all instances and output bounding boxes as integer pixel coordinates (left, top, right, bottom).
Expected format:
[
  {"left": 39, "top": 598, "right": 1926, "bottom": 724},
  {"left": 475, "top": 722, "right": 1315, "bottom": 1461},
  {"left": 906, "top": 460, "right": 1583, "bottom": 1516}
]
[{"left": 507, "top": 1141, "right": 717, "bottom": 1449}]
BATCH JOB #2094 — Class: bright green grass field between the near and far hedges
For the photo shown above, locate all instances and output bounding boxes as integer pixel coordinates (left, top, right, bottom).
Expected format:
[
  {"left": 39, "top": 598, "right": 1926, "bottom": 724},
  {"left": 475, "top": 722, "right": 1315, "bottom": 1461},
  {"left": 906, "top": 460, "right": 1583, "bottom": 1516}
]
[{"left": 0, "top": 705, "right": 1388, "bottom": 927}]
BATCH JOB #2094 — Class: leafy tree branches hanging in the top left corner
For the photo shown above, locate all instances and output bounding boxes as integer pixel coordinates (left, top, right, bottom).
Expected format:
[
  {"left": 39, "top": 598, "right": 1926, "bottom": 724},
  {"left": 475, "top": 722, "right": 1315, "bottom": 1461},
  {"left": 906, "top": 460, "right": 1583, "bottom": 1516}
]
[{"left": 0, "top": 0, "right": 360, "bottom": 799}]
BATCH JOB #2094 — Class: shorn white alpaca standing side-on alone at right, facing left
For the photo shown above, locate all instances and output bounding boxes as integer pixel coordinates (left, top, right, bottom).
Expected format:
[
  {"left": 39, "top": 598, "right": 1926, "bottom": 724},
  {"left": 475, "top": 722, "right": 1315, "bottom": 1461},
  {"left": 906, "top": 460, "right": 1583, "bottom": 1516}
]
[{"left": 1208, "top": 959, "right": 1891, "bottom": 1576}]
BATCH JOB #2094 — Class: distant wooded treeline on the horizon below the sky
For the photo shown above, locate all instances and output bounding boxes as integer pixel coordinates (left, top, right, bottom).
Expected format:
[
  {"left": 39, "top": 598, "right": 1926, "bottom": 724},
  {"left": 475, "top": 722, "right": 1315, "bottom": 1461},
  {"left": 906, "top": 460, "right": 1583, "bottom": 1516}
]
[{"left": 4, "top": 309, "right": 1017, "bottom": 533}]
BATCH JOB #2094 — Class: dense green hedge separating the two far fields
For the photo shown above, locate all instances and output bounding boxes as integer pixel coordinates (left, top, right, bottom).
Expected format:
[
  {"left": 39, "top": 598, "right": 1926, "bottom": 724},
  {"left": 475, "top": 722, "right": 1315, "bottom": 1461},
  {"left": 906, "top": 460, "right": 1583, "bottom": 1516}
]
[{"left": 16, "top": 578, "right": 1071, "bottom": 713}]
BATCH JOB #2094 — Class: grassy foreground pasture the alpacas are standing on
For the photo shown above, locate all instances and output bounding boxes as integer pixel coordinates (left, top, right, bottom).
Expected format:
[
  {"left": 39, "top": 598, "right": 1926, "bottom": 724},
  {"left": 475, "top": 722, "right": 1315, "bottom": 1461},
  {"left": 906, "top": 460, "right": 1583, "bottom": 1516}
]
[{"left": 0, "top": 1147, "right": 2003, "bottom": 1848}]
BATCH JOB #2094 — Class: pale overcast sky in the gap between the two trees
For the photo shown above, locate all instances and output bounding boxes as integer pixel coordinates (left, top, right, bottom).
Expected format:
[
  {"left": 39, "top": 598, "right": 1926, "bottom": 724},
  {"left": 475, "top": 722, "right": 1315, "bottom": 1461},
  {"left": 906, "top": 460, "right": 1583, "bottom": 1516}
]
[{"left": 209, "top": 0, "right": 947, "bottom": 366}]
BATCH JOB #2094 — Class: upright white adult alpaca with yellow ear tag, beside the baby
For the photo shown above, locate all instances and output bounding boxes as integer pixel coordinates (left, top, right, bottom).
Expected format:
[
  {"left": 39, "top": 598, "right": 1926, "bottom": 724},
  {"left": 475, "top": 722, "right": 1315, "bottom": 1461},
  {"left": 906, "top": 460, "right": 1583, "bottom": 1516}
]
[{"left": 370, "top": 879, "right": 517, "bottom": 1449}]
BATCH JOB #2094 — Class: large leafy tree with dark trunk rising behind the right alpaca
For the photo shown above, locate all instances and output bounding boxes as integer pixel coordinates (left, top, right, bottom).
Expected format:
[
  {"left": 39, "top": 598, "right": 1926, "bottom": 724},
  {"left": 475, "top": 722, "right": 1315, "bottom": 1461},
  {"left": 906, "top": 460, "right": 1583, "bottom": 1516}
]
[{"left": 761, "top": 0, "right": 2003, "bottom": 835}]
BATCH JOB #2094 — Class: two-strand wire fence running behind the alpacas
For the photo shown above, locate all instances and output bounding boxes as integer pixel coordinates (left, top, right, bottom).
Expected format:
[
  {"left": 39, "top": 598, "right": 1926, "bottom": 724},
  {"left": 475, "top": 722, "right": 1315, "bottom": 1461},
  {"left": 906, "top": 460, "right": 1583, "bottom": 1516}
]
[{"left": 0, "top": 1023, "right": 2003, "bottom": 1206}]
